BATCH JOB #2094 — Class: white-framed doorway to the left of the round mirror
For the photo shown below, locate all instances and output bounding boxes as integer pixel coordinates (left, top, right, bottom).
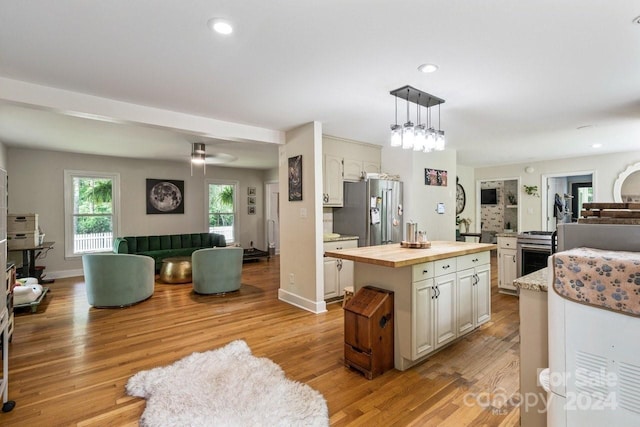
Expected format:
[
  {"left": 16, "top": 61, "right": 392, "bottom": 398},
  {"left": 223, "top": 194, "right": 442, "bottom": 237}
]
[{"left": 541, "top": 171, "right": 595, "bottom": 231}]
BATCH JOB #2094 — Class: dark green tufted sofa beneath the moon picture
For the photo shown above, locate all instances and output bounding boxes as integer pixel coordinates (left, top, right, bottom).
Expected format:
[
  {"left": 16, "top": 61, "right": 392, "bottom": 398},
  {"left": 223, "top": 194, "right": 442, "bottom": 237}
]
[{"left": 113, "top": 233, "right": 227, "bottom": 273}]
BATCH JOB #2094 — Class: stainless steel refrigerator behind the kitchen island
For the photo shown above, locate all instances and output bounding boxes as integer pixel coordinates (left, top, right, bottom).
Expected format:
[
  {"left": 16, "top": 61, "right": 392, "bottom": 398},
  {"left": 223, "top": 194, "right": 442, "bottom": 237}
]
[{"left": 333, "top": 179, "right": 403, "bottom": 246}]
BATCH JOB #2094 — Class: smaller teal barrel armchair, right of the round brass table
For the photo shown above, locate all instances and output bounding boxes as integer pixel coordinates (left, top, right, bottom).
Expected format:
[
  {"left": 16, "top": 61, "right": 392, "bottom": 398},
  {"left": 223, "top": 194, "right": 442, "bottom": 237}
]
[{"left": 191, "top": 247, "right": 244, "bottom": 294}]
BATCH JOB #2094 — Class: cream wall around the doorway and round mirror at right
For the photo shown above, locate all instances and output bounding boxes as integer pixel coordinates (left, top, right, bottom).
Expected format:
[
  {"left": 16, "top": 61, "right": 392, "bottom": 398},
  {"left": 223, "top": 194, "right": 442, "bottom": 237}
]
[{"left": 475, "top": 151, "right": 640, "bottom": 231}]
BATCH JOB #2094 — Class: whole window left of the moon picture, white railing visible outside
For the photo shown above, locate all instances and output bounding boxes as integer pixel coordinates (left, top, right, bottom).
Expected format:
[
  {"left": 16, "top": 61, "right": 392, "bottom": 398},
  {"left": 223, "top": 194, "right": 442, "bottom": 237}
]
[{"left": 64, "top": 171, "right": 120, "bottom": 257}]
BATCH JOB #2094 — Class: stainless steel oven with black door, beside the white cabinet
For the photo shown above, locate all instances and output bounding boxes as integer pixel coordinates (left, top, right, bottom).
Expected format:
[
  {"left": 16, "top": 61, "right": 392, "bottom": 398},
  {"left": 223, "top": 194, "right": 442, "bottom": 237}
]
[{"left": 516, "top": 231, "right": 556, "bottom": 277}]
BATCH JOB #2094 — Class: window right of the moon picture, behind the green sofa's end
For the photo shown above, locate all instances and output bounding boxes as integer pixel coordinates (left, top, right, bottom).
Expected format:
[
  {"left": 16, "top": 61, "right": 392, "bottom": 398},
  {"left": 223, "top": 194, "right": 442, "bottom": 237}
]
[{"left": 207, "top": 181, "right": 238, "bottom": 244}]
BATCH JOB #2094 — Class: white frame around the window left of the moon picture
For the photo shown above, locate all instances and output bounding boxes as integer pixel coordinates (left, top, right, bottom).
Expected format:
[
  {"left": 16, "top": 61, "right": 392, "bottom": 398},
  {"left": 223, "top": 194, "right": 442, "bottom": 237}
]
[{"left": 64, "top": 169, "right": 120, "bottom": 259}]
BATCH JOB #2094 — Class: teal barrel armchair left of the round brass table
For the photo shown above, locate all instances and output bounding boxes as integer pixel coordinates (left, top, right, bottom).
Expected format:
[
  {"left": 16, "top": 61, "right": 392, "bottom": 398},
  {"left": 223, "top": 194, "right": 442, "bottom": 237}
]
[{"left": 82, "top": 254, "right": 155, "bottom": 307}]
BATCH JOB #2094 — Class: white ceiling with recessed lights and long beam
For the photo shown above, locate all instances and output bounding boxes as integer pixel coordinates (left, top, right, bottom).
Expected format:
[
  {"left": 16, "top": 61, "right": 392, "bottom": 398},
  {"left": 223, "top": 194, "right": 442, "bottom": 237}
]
[{"left": 0, "top": 0, "right": 640, "bottom": 168}]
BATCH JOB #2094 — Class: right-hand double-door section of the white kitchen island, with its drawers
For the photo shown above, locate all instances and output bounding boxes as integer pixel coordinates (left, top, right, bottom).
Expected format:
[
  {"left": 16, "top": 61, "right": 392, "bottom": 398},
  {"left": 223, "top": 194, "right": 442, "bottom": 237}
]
[{"left": 456, "top": 252, "right": 491, "bottom": 335}]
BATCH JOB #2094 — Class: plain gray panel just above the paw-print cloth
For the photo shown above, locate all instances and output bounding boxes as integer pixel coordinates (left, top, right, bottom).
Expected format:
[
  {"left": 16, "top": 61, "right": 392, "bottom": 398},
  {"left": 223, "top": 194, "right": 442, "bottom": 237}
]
[{"left": 558, "top": 223, "right": 640, "bottom": 252}]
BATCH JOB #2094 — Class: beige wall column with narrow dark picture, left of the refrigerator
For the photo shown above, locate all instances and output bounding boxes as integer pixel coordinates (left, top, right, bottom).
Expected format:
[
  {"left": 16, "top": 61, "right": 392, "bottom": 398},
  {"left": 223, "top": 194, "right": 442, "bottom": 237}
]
[{"left": 278, "top": 122, "right": 326, "bottom": 313}]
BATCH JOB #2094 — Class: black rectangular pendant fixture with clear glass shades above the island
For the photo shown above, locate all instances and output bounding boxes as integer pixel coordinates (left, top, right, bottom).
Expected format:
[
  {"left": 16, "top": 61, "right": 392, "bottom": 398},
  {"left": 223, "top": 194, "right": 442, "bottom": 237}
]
[{"left": 390, "top": 85, "right": 445, "bottom": 152}]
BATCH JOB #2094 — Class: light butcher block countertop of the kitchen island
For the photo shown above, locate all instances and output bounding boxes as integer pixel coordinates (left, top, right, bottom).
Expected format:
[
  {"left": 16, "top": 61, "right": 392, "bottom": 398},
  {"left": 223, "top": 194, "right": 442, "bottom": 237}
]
[{"left": 325, "top": 241, "right": 497, "bottom": 268}]
